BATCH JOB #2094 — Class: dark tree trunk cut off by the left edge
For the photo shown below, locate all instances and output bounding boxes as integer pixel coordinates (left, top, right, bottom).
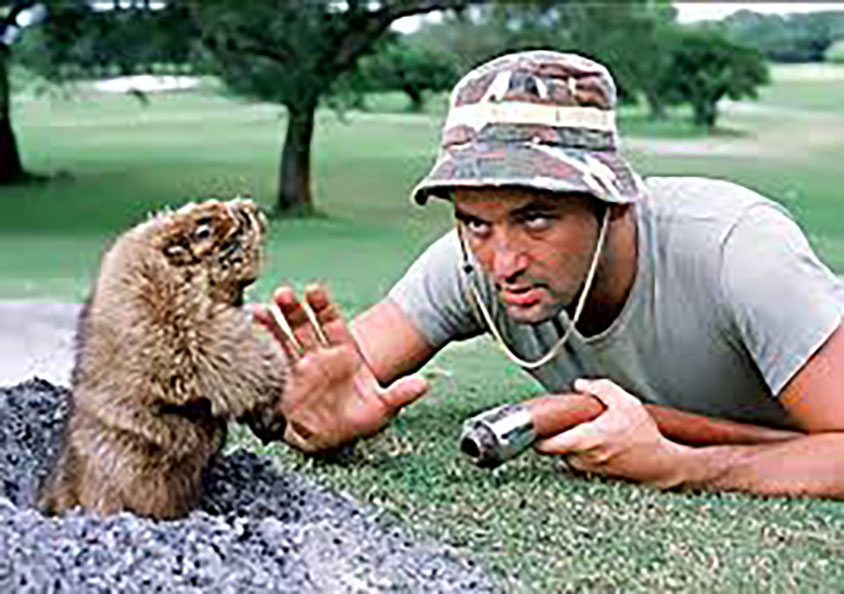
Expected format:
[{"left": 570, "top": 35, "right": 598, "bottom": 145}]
[{"left": 0, "top": 1, "right": 44, "bottom": 184}]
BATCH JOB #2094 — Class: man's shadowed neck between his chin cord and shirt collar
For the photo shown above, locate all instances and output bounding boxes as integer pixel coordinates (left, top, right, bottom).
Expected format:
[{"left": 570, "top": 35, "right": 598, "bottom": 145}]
[{"left": 569, "top": 206, "right": 639, "bottom": 336}]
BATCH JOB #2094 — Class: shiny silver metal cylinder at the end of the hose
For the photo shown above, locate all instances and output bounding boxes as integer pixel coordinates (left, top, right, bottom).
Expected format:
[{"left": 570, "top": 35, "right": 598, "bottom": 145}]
[{"left": 459, "top": 404, "right": 536, "bottom": 468}]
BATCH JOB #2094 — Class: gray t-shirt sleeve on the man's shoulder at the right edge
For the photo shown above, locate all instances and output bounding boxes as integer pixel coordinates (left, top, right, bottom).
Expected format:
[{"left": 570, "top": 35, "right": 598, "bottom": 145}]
[{"left": 721, "top": 203, "right": 844, "bottom": 395}]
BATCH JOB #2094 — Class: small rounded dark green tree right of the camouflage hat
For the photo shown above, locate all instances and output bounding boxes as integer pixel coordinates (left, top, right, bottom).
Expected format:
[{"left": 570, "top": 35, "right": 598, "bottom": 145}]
[{"left": 655, "top": 27, "right": 769, "bottom": 129}]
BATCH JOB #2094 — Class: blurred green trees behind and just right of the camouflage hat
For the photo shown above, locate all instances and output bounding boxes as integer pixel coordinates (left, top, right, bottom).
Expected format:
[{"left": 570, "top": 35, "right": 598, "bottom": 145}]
[{"left": 368, "top": 0, "right": 768, "bottom": 128}]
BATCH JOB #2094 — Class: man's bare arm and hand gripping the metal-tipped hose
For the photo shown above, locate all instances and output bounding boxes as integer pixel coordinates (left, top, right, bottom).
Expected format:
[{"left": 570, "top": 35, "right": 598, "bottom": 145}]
[{"left": 537, "top": 325, "right": 844, "bottom": 498}]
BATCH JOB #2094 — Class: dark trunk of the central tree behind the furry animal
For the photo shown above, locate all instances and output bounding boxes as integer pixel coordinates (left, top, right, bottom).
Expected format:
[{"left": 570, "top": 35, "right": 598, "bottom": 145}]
[{"left": 276, "top": 101, "right": 316, "bottom": 216}]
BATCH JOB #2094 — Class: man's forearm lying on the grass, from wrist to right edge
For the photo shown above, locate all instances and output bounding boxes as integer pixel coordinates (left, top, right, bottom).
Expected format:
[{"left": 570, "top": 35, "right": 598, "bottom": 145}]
[{"left": 678, "top": 433, "right": 844, "bottom": 498}]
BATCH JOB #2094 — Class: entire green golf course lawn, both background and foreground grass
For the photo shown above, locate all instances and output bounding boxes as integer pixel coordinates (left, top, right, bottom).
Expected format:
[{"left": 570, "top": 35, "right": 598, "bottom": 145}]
[{"left": 0, "top": 68, "right": 844, "bottom": 592}]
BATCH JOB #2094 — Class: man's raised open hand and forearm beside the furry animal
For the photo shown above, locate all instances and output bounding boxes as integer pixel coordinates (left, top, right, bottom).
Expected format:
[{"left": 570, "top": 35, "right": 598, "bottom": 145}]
[{"left": 253, "top": 285, "right": 435, "bottom": 452}]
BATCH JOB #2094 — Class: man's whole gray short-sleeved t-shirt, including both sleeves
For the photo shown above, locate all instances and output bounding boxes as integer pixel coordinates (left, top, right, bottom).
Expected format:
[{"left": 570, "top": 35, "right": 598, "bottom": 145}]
[{"left": 389, "top": 178, "right": 844, "bottom": 426}]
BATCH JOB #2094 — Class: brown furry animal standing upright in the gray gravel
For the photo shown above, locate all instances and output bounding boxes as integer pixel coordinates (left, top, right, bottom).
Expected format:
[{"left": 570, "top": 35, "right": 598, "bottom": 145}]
[{"left": 39, "top": 200, "right": 285, "bottom": 518}]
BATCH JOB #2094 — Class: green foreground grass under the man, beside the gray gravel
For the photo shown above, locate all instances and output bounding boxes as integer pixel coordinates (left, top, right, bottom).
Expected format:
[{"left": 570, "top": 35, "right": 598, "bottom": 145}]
[{"left": 232, "top": 339, "right": 844, "bottom": 592}]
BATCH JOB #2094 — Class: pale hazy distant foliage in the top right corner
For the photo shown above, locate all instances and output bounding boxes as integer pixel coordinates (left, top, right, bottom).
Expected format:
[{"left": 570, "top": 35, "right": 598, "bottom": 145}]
[{"left": 721, "top": 10, "right": 844, "bottom": 63}]
